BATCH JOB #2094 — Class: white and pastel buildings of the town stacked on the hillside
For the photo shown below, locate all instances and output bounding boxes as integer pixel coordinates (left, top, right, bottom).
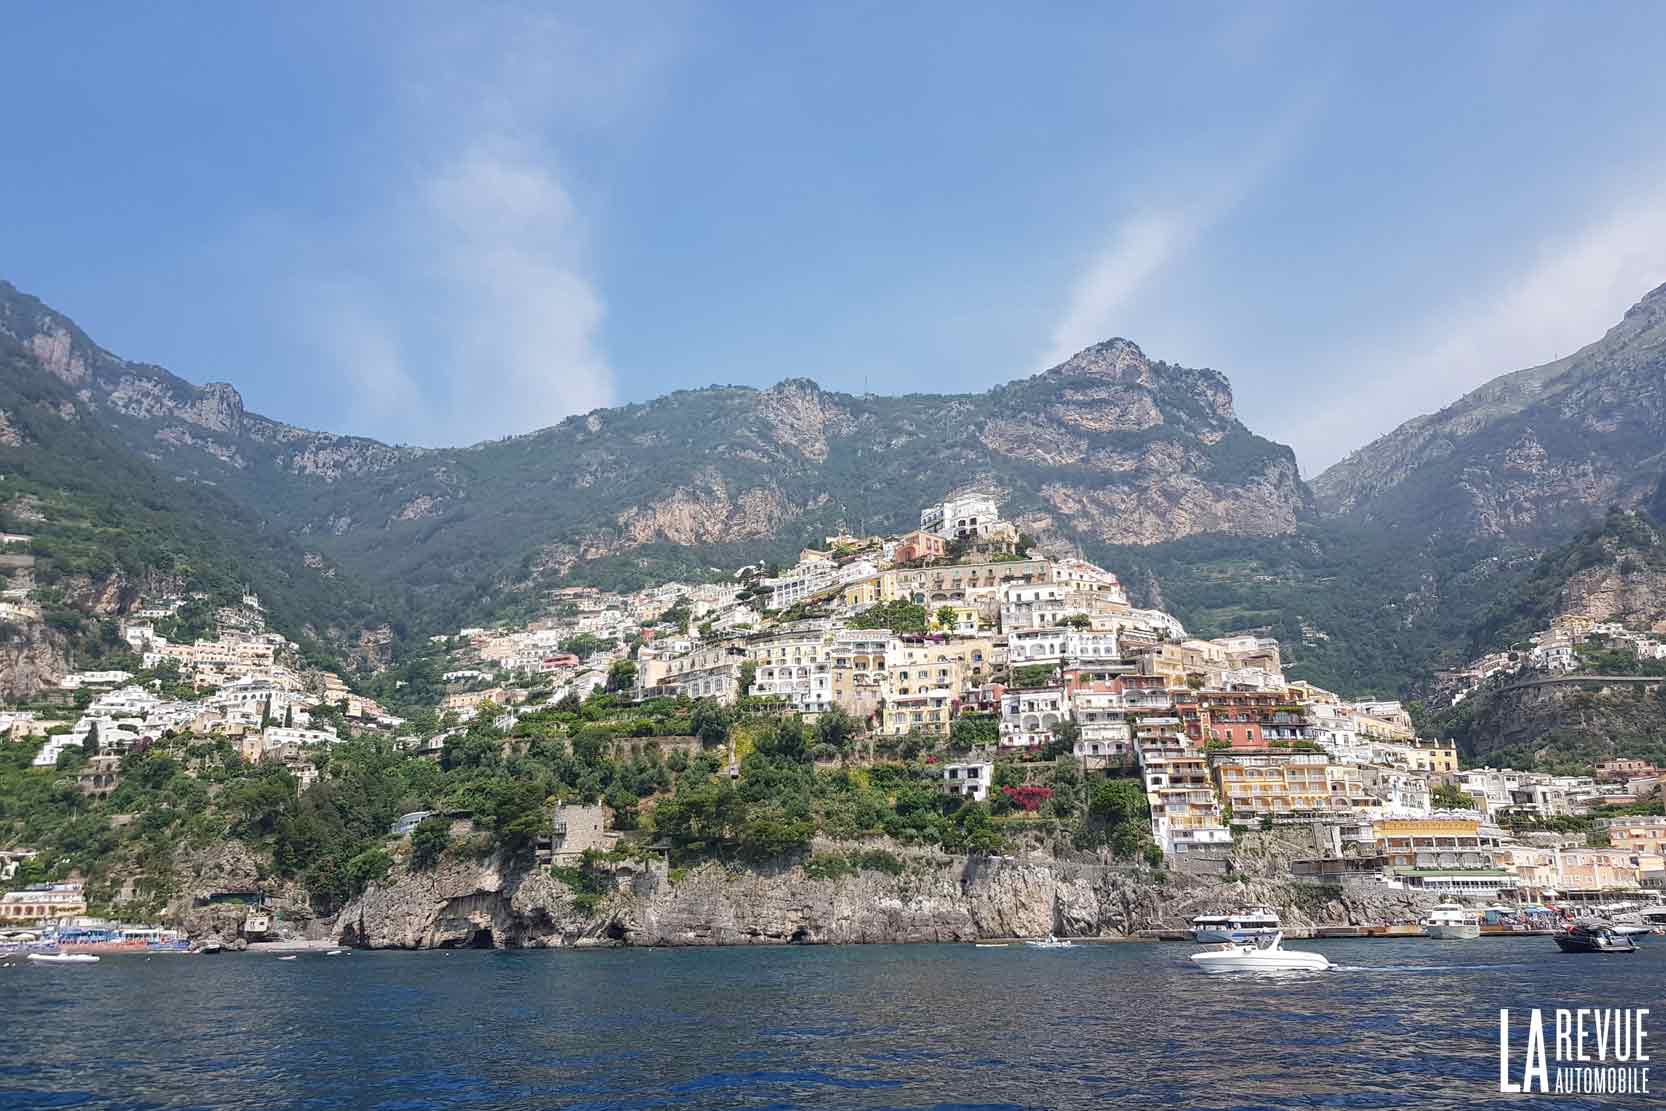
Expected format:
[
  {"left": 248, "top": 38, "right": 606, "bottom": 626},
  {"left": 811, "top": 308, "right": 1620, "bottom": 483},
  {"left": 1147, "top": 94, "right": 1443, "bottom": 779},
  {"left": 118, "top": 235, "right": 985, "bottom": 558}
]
[{"left": 0, "top": 491, "right": 1666, "bottom": 946}]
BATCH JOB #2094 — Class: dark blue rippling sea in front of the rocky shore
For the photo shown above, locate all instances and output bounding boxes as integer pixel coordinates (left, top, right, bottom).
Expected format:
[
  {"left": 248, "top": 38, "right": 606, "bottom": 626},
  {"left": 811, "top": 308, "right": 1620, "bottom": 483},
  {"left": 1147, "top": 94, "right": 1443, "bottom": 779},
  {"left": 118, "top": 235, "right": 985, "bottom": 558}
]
[{"left": 0, "top": 938, "right": 1666, "bottom": 1111}]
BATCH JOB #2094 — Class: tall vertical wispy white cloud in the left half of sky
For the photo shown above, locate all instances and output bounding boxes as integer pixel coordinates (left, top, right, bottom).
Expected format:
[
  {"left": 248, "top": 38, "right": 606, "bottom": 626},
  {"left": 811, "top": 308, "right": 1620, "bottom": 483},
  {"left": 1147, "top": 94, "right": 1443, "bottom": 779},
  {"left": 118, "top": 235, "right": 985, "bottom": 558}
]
[{"left": 293, "top": 7, "right": 665, "bottom": 443}]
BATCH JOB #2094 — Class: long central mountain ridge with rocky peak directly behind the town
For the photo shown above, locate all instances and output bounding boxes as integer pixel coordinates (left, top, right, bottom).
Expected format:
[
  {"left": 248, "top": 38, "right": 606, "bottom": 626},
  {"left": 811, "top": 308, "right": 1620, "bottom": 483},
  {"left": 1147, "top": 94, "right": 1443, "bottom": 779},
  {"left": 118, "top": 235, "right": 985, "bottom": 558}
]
[{"left": 0, "top": 283, "right": 1314, "bottom": 625}]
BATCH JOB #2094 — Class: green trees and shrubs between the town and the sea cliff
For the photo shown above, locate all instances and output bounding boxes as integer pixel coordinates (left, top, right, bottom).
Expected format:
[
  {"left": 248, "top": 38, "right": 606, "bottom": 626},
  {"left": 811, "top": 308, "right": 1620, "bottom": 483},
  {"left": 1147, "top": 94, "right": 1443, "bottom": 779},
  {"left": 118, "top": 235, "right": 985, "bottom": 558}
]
[{"left": 0, "top": 695, "right": 1153, "bottom": 913}]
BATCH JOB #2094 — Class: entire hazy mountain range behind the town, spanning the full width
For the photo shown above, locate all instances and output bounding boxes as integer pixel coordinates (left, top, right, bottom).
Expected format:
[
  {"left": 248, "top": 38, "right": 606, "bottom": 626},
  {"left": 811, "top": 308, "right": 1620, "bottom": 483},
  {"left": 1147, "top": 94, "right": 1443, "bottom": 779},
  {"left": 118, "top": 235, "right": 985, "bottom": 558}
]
[{"left": 0, "top": 274, "right": 1666, "bottom": 702}]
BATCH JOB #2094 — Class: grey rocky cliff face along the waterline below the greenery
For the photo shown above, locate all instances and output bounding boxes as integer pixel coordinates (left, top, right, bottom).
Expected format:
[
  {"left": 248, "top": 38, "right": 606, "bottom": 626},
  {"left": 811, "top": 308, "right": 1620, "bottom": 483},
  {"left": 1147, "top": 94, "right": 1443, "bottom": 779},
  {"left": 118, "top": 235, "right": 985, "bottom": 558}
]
[{"left": 335, "top": 839, "right": 1423, "bottom": 948}]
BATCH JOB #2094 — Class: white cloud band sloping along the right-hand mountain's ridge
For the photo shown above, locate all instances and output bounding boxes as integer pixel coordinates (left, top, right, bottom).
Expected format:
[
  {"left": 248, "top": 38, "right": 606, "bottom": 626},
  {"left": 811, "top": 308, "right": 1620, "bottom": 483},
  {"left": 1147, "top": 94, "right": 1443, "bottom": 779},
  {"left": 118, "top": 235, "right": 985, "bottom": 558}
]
[{"left": 1294, "top": 184, "right": 1666, "bottom": 473}]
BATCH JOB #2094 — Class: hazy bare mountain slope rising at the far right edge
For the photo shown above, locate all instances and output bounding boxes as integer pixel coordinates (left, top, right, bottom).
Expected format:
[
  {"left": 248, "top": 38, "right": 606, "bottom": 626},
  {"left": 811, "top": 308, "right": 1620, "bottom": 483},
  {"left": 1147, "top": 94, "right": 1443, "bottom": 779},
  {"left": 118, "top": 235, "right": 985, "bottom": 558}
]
[{"left": 1313, "top": 285, "right": 1666, "bottom": 543}]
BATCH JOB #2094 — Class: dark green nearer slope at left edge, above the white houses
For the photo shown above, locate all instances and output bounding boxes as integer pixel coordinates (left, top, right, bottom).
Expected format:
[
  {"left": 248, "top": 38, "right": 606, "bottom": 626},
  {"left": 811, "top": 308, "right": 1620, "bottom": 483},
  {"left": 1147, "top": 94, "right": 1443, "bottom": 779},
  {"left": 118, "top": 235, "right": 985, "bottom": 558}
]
[{"left": 0, "top": 316, "right": 377, "bottom": 696}]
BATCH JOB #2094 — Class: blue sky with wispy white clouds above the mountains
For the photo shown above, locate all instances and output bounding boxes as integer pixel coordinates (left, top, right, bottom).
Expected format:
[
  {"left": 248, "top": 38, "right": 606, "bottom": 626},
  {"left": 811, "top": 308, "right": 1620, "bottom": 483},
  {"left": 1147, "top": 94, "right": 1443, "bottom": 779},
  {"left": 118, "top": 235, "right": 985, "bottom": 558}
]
[{"left": 0, "top": 2, "right": 1666, "bottom": 475}]
